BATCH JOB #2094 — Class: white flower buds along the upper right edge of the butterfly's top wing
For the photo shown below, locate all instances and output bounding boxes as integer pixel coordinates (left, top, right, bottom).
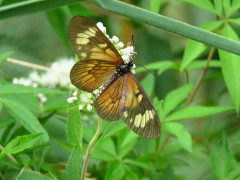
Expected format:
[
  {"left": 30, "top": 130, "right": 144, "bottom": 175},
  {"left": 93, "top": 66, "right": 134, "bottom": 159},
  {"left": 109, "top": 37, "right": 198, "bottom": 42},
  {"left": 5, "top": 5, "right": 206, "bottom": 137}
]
[{"left": 97, "top": 22, "right": 136, "bottom": 74}]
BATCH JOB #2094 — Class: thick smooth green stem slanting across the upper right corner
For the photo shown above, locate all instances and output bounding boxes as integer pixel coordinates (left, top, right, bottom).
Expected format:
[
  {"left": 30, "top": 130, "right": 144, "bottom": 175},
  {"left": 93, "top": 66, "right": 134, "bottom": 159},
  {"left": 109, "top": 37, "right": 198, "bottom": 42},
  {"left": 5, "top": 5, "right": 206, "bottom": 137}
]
[{"left": 97, "top": 0, "right": 240, "bottom": 55}]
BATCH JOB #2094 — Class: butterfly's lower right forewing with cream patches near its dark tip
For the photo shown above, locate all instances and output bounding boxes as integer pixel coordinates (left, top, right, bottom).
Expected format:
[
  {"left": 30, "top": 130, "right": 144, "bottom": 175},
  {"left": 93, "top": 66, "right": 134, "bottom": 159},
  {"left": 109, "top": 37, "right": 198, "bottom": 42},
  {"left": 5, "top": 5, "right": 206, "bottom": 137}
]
[{"left": 120, "top": 73, "right": 161, "bottom": 138}]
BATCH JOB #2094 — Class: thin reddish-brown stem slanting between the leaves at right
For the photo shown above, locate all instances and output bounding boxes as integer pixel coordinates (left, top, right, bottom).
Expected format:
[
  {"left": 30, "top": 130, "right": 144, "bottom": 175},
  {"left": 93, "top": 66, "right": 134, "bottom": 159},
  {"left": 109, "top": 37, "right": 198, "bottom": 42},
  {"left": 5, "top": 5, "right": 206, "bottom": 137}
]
[{"left": 184, "top": 47, "right": 215, "bottom": 107}]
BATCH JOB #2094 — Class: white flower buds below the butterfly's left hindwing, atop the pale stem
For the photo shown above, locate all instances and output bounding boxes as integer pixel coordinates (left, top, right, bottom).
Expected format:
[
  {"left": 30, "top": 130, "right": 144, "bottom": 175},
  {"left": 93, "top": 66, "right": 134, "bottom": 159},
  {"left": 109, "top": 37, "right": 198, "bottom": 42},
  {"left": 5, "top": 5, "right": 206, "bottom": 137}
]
[{"left": 67, "top": 86, "right": 102, "bottom": 111}]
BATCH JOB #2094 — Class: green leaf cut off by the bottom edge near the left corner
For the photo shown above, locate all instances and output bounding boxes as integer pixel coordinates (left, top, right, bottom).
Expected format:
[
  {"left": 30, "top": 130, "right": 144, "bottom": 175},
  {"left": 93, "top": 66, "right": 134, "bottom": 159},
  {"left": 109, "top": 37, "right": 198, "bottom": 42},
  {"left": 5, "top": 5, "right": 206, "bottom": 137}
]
[{"left": 15, "top": 171, "right": 53, "bottom": 180}]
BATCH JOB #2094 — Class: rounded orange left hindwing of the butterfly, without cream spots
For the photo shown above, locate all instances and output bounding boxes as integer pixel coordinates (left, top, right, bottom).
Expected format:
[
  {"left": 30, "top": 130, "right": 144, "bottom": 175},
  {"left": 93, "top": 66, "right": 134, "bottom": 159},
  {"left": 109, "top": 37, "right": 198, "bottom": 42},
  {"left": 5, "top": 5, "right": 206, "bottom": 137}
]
[{"left": 70, "top": 60, "right": 116, "bottom": 92}]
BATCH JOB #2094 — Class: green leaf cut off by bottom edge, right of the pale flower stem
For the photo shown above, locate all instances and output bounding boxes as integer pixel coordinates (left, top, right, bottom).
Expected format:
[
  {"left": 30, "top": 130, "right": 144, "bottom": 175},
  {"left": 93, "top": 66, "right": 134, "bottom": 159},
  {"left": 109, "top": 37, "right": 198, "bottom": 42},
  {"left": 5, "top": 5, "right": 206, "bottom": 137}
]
[{"left": 104, "top": 161, "right": 125, "bottom": 180}]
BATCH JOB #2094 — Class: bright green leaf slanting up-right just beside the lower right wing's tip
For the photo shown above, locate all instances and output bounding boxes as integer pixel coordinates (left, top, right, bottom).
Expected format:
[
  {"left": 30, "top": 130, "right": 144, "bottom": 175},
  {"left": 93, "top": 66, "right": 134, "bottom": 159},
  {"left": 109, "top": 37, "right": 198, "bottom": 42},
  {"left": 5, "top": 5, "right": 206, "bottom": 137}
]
[{"left": 161, "top": 84, "right": 193, "bottom": 118}]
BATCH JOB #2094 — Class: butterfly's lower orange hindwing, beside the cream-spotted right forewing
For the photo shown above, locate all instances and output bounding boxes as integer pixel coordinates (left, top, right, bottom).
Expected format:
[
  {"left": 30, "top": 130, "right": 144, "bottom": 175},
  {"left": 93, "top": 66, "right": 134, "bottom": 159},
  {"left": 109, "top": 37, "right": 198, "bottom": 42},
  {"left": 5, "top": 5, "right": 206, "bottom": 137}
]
[{"left": 94, "top": 76, "right": 123, "bottom": 121}]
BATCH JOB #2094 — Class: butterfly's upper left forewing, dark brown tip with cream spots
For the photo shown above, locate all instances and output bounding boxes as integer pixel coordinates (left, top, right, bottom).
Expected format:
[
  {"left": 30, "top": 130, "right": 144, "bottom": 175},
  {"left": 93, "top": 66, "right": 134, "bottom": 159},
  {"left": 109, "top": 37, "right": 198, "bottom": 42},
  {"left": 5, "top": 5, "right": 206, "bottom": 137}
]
[{"left": 69, "top": 16, "right": 123, "bottom": 66}]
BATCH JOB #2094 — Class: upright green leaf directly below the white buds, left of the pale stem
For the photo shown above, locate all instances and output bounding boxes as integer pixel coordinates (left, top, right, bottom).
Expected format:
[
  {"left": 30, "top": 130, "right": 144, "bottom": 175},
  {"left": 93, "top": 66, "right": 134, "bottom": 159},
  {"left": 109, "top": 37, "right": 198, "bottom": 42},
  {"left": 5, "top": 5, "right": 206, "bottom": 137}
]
[{"left": 66, "top": 101, "right": 83, "bottom": 147}]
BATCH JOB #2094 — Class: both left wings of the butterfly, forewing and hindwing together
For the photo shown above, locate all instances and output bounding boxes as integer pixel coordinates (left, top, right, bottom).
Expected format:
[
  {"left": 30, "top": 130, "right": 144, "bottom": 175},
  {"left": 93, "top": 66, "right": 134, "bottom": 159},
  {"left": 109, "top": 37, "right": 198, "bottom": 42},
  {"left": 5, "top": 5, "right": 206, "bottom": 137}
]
[{"left": 69, "top": 16, "right": 123, "bottom": 92}]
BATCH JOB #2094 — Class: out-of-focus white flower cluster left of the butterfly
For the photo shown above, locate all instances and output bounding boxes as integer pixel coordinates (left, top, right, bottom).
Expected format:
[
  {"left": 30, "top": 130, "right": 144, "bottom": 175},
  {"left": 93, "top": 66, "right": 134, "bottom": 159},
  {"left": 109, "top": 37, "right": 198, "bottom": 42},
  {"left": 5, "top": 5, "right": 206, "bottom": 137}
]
[{"left": 12, "top": 58, "right": 75, "bottom": 102}]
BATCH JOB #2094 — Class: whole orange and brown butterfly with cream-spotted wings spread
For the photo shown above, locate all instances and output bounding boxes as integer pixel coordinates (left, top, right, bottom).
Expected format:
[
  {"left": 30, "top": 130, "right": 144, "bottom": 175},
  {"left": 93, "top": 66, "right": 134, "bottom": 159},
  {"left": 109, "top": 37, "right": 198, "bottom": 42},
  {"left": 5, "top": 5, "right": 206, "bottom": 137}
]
[{"left": 69, "top": 16, "right": 161, "bottom": 138}]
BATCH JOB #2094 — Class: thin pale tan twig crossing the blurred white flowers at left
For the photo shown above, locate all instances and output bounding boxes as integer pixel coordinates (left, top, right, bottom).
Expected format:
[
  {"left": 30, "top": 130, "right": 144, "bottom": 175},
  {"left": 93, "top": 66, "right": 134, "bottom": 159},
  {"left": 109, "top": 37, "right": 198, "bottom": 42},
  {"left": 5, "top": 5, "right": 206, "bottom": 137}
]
[{"left": 7, "top": 58, "right": 69, "bottom": 76}]
